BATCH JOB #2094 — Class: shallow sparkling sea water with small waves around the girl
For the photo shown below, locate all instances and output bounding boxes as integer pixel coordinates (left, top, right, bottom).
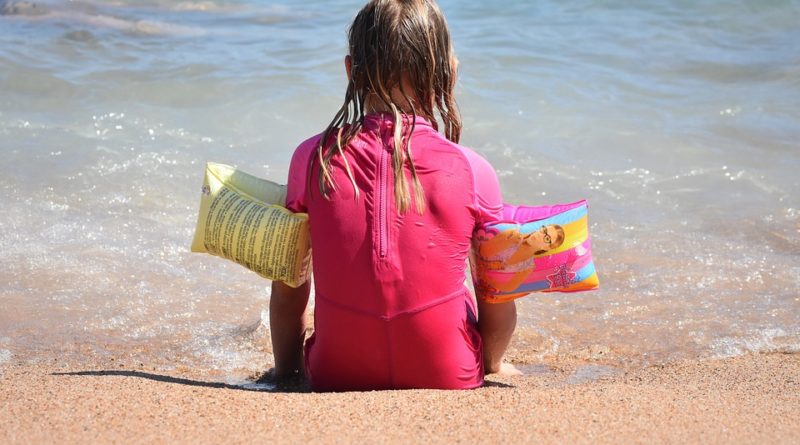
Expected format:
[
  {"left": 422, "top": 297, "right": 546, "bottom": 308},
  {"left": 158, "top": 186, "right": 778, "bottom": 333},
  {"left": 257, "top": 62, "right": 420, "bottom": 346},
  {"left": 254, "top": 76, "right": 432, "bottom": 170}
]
[{"left": 0, "top": 0, "right": 800, "bottom": 375}]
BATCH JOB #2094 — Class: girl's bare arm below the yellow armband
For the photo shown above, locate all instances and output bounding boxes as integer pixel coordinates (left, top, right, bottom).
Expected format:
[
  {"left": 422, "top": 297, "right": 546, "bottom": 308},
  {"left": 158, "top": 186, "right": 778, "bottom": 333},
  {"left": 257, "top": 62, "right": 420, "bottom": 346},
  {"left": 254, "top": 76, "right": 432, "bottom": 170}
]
[{"left": 269, "top": 281, "right": 310, "bottom": 379}]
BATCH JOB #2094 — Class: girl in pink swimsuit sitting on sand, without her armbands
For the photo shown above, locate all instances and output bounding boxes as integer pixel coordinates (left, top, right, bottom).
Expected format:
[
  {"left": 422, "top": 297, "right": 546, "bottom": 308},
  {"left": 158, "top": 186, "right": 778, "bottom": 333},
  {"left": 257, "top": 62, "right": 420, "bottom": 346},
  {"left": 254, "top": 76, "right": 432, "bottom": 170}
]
[{"left": 270, "top": 0, "right": 516, "bottom": 391}]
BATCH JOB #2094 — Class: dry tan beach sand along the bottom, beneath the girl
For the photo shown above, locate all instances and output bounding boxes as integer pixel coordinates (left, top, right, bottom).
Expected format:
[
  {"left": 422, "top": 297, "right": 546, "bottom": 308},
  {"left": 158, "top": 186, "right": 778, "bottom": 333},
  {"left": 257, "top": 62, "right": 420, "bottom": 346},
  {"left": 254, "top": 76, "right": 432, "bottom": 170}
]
[{"left": 0, "top": 353, "right": 800, "bottom": 444}]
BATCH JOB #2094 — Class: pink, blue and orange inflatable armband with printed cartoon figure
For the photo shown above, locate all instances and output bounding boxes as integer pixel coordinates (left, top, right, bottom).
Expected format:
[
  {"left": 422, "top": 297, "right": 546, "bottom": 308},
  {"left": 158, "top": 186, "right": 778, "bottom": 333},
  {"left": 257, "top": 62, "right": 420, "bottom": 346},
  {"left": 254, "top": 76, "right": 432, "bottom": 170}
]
[{"left": 470, "top": 200, "right": 599, "bottom": 303}]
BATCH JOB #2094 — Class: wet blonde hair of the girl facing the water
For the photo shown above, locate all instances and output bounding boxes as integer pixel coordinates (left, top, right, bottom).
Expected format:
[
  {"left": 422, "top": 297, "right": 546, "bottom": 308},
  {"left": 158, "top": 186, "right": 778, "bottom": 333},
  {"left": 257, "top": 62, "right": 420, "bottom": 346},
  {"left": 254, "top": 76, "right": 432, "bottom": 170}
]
[{"left": 317, "top": 0, "right": 461, "bottom": 213}]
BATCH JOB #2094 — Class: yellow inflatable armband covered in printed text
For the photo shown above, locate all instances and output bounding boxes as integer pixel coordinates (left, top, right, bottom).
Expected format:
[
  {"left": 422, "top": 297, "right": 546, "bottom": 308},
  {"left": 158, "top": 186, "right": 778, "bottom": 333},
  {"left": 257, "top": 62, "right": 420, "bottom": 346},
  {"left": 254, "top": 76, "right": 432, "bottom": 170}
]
[{"left": 192, "top": 162, "right": 311, "bottom": 287}]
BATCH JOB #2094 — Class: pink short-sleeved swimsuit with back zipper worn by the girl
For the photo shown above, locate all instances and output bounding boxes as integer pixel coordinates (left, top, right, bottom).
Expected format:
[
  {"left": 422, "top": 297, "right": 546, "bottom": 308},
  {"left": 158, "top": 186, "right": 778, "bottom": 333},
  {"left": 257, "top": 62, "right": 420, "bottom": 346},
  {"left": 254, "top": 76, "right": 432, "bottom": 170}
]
[{"left": 286, "top": 114, "right": 503, "bottom": 391}]
